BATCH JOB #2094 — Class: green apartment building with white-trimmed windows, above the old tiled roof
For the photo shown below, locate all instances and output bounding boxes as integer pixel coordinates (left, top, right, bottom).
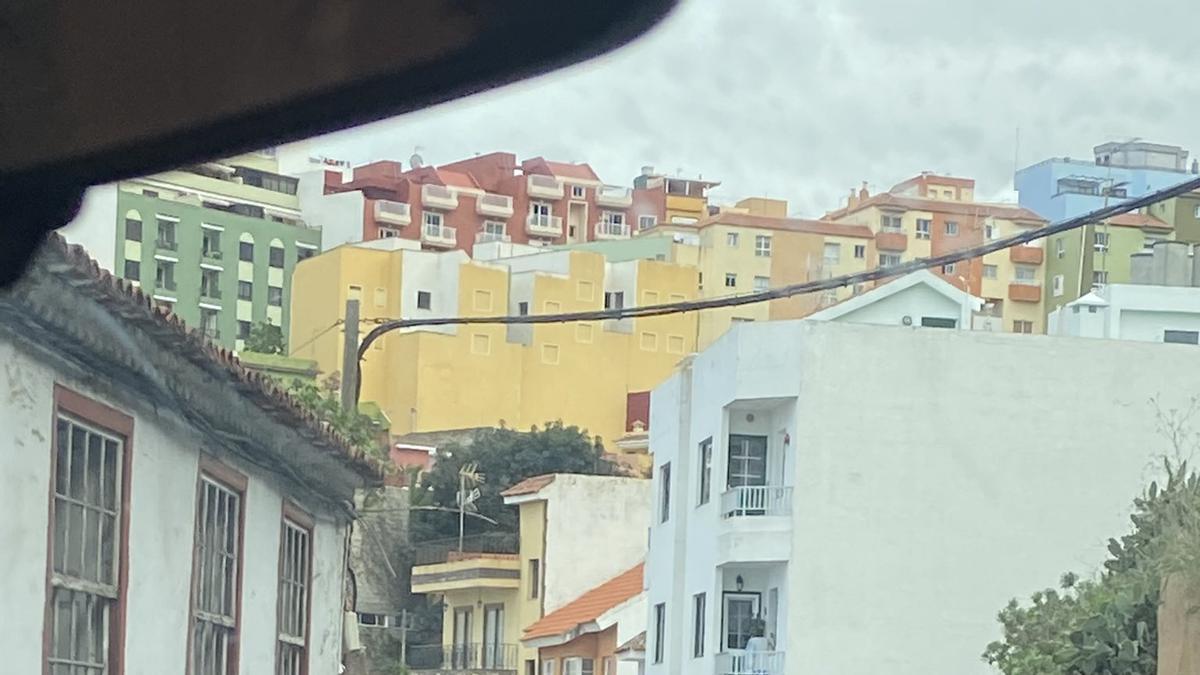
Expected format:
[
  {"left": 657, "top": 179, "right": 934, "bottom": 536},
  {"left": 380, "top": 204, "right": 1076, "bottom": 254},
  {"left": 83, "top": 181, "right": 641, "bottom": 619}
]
[{"left": 112, "top": 155, "right": 320, "bottom": 351}]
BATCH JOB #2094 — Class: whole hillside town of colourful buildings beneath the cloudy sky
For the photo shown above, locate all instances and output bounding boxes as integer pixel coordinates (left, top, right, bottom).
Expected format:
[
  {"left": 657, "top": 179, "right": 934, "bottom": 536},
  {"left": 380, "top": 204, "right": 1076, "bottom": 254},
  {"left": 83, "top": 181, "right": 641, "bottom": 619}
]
[{"left": 7, "top": 138, "right": 1200, "bottom": 675}]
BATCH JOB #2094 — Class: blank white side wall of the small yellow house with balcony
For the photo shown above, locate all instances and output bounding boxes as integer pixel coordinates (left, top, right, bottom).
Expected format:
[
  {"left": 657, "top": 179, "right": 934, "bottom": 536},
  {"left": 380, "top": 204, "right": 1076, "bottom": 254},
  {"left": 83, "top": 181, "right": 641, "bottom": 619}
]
[{"left": 541, "top": 474, "right": 650, "bottom": 614}]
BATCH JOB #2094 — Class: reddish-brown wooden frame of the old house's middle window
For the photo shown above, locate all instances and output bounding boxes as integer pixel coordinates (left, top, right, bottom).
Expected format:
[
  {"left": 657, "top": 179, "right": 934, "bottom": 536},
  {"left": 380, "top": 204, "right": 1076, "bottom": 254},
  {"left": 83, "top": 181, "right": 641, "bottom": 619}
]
[{"left": 184, "top": 454, "right": 246, "bottom": 675}]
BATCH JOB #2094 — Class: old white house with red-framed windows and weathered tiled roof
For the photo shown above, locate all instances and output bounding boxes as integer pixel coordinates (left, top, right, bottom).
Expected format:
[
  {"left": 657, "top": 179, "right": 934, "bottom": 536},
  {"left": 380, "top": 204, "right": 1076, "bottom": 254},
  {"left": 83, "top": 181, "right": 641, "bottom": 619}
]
[{"left": 0, "top": 237, "right": 379, "bottom": 675}]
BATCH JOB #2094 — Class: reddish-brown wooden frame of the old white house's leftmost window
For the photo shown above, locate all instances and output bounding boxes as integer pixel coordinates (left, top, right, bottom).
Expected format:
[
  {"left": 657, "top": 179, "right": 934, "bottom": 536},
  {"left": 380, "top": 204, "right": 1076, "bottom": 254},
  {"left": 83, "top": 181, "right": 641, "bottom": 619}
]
[{"left": 42, "top": 382, "right": 133, "bottom": 675}]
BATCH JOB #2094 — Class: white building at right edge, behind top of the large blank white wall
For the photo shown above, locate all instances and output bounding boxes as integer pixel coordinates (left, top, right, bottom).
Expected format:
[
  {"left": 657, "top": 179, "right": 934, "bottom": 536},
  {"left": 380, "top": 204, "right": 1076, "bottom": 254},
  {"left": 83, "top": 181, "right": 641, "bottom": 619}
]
[{"left": 1046, "top": 241, "right": 1200, "bottom": 345}]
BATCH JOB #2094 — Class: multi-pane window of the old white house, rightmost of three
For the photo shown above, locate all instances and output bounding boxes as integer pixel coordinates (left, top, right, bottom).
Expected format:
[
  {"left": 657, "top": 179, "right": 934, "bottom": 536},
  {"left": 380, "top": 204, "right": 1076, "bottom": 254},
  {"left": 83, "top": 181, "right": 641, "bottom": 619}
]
[{"left": 276, "top": 507, "right": 312, "bottom": 675}]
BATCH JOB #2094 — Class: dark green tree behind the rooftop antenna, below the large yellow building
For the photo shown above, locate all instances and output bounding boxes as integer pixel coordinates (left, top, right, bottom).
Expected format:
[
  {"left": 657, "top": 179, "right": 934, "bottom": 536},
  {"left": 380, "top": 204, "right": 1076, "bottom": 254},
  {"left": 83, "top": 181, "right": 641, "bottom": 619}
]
[{"left": 413, "top": 422, "right": 616, "bottom": 542}]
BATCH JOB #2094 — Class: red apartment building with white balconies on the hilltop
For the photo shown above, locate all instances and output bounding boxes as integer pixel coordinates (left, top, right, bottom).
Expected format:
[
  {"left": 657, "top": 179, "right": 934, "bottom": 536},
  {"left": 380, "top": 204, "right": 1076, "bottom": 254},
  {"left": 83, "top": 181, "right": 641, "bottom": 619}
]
[{"left": 324, "top": 153, "right": 666, "bottom": 253}]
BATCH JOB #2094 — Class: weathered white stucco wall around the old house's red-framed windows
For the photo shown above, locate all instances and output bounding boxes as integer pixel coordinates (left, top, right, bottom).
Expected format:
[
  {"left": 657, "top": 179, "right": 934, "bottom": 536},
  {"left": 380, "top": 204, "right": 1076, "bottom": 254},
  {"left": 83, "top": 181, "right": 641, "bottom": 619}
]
[{"left": 0, "top": 342, "right": 344, "bottom": 675}]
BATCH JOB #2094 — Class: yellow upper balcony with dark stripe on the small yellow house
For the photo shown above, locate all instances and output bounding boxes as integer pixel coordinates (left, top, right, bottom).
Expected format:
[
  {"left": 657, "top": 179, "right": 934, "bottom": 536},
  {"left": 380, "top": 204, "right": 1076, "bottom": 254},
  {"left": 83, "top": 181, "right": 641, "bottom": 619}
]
[{"left": 413, "top": 533, "right": 521, "bottom": 593}]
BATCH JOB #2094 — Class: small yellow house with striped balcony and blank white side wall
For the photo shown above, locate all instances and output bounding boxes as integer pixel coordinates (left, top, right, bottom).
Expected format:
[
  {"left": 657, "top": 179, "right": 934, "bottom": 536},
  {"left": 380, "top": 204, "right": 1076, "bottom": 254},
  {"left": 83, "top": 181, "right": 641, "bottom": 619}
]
[{"left": 409, "top": 474, "right": 653, "bottom": 673}]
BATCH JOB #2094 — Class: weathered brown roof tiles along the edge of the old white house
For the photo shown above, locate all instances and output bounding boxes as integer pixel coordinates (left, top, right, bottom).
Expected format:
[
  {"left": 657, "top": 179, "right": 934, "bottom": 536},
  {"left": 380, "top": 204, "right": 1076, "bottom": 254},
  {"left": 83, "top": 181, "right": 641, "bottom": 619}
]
[{"left": 41, "top": 234, "right": 383, "bottom": 482}]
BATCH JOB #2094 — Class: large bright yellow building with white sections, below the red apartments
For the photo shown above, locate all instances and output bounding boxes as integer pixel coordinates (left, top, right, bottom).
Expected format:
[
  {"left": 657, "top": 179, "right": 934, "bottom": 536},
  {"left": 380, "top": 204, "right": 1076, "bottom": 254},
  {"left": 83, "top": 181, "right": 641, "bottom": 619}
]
[{"left": 292, "top": 239, "right": 696, "bottom": 441}]
